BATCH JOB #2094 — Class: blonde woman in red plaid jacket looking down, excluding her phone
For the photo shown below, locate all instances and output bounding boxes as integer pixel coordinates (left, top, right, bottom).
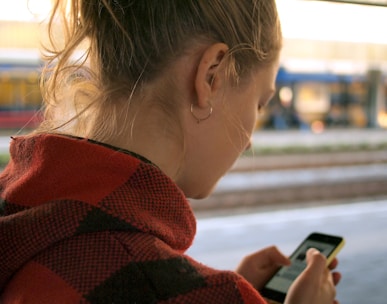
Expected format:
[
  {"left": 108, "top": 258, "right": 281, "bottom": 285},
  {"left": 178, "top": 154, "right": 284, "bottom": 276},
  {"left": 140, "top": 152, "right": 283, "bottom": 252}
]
[{"left": 0, "top": 0, "right": 340, "bottom": 304}]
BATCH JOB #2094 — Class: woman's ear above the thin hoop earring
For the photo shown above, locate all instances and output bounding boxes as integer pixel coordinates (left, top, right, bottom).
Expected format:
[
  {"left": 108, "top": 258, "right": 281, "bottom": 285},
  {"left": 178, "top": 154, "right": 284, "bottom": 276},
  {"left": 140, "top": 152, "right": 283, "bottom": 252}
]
[{"left": 195, "top": 43, "right": 229, "bottom": 108}]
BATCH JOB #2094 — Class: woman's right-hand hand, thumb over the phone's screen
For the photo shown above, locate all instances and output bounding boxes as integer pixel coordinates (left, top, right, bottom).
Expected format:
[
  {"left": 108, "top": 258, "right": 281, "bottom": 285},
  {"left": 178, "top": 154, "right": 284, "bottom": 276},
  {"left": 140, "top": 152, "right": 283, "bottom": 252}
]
[{"left": 285, "top": 248, "right": 341, "bottom": 304}]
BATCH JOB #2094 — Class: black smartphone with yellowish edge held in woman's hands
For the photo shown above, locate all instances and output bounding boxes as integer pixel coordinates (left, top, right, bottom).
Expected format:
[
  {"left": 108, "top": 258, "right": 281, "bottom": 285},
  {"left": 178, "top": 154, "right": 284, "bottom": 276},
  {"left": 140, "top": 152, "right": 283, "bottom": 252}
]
[{"left": 260, "top": 232, "right": 345, "bottom": 303}]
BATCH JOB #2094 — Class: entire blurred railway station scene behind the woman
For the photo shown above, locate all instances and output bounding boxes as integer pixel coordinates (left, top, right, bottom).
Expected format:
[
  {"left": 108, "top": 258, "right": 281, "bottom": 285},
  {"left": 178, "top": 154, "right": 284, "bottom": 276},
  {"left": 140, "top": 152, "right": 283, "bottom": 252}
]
[{"left": 0, "top": 0, "right": 387, "bottom": 304}]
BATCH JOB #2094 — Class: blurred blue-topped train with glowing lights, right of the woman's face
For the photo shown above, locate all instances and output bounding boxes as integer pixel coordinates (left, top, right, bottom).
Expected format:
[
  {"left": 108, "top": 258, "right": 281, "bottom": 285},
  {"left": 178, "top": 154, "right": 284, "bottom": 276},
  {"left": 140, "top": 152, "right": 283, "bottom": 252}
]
[{"left": 259, "top": 67, "right": 374, "bottom": 132}]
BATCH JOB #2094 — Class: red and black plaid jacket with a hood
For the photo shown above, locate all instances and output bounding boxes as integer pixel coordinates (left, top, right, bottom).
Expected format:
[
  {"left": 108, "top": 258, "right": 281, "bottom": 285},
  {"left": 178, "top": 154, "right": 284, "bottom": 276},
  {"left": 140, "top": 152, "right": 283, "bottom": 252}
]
[{"left": 0, "top": 135, "right": 265, "bottom": 304}]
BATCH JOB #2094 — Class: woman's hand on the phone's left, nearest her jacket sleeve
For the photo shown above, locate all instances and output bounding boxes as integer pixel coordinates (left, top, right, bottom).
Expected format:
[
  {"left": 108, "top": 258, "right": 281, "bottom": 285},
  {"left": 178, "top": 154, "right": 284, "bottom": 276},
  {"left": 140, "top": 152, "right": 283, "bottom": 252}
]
[{"left": 236, "top": 246, "right": 290, "bottom": 290}]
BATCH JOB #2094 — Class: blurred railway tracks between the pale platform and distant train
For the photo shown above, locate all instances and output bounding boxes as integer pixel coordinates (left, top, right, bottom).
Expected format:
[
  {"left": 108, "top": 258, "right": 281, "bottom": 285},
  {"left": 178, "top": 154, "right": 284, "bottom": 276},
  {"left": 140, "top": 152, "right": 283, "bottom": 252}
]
[{"left": 191, "top": 150, "right": 387, "bottom": 212}]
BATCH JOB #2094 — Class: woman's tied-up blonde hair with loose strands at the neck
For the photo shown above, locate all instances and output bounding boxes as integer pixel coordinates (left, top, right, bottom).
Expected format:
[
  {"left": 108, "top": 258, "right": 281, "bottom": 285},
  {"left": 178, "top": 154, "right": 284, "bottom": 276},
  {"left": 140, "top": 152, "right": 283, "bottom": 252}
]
[{"left": 39, "top": 0, "right": 282, "bottom": 141}]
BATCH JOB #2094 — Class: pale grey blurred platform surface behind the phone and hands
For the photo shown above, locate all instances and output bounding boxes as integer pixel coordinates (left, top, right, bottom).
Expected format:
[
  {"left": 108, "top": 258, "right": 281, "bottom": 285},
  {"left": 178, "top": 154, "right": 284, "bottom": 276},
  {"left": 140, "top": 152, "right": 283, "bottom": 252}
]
[{"left": 188, "top": 199, "right": 387, "bottom": 304}]
